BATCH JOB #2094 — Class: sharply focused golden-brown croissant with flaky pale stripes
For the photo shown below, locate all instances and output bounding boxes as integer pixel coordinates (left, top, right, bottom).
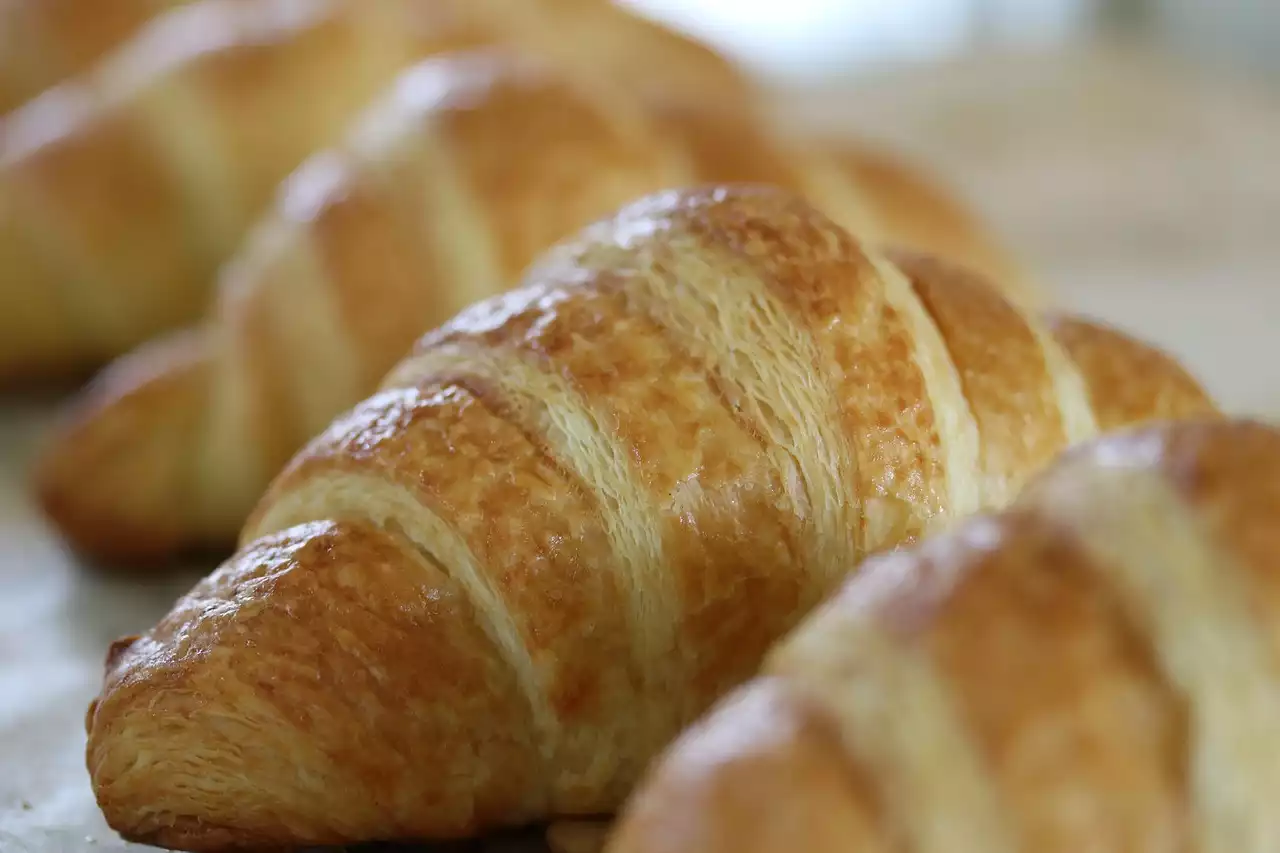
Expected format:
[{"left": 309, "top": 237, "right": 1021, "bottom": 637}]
[{"left": 87, "top": 187, "right": 1213, "bottom": 852}]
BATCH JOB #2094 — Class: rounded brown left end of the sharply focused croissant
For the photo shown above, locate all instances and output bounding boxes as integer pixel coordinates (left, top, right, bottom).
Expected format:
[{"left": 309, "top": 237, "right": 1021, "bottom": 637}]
[{"left": 87, "top": 514, "right": 555, "bottom": 850}]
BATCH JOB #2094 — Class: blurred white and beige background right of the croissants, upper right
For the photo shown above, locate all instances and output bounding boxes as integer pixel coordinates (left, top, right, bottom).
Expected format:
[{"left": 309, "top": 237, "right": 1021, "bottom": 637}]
[{"left": 626, "top": 0, "right": 1280, "bottom": 414}]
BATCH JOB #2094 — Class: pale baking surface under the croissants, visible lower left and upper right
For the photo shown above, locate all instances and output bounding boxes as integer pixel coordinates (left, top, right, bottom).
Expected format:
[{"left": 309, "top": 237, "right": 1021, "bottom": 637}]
[{"left": 0, "top": 44, "right": 1280, "bottom": 853}]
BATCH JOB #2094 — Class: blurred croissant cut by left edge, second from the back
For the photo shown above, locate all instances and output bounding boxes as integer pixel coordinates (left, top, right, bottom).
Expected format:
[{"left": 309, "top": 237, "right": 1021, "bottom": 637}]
[{"left": 0, "top": 0, "right": 746, "bottom": 383}]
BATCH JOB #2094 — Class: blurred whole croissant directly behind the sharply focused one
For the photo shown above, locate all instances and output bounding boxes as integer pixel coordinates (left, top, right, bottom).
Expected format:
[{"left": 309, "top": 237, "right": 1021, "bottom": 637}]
[{"left": 37, "top": 54, "right": 1021, "bottom": 560}]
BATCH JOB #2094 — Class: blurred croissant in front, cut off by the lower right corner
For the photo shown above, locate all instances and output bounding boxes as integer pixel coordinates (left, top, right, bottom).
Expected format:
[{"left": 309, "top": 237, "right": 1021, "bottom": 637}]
[{"left": 609, "top": 420, "right": 1280, "bottom": 853}]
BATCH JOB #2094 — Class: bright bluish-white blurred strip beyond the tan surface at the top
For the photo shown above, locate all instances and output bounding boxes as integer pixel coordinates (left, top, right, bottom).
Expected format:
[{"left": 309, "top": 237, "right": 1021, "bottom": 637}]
[{"left": 623, "top": 0, "right": 1280, "bottom": 82}]
